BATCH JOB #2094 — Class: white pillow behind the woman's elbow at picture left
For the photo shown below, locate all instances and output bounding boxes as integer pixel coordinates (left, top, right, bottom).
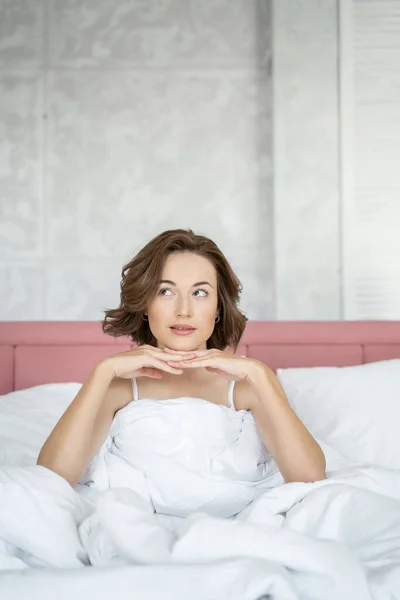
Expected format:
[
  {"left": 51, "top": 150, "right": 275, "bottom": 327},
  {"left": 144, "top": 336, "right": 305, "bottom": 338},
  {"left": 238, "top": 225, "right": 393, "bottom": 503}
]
[{"left": 0, "top": 383, "right": 82, "bottom": 466}]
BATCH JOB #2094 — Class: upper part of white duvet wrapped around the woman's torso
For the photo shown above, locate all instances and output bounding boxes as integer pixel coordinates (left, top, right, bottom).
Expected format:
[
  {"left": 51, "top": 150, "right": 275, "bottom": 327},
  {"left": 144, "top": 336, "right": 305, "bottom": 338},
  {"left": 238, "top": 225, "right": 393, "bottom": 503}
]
[{"left": 82, "top": 398, "right": 283, "bottom": 518}]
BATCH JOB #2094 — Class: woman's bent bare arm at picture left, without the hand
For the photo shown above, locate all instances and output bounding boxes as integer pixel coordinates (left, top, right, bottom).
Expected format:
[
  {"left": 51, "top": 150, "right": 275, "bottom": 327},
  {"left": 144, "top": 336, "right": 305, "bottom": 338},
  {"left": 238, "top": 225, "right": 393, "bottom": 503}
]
[{"left": 37, "top": 363, "right": 132, "bottom": 486}]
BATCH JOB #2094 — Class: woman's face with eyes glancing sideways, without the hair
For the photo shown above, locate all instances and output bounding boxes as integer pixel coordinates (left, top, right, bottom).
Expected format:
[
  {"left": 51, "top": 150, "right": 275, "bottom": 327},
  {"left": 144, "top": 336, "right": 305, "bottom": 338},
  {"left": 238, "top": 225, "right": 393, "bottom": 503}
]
[{"left": 147, "top": 252, "right": 218, "bottom": 350}]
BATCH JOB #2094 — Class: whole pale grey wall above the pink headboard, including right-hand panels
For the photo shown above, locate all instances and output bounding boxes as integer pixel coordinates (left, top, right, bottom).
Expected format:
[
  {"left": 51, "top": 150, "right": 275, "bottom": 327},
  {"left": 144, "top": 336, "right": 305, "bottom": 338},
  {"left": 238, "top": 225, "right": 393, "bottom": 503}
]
[{"left": 7, "top": 0, "right": 400, "bottom": 320}]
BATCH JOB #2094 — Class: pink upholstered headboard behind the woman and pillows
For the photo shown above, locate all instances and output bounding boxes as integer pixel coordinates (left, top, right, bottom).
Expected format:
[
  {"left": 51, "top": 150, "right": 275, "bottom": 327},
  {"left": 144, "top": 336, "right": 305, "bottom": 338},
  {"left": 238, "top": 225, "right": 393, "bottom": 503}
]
[{"left": 0, "top": 321, "right": 400, "bottom": 394}]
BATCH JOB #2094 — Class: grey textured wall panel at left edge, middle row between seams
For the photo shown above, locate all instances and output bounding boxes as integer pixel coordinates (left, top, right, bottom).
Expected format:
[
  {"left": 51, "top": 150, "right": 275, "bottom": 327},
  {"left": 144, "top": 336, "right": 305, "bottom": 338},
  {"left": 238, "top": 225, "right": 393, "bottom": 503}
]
[{"left": 0, "top": 71, "right": 43, "bottom": 259}]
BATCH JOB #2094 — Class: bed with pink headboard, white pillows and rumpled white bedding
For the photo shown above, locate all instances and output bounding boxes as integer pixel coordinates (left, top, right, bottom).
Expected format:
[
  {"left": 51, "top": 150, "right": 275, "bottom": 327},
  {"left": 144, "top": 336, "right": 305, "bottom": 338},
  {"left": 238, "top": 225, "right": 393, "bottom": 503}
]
[{"left": 0, "top": 321, "right": 400, "bottom": 600}]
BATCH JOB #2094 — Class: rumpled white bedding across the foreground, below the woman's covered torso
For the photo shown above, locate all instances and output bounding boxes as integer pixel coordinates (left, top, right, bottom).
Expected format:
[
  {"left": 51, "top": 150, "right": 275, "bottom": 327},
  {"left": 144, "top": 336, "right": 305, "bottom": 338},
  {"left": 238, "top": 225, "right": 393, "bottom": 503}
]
[{"left": 0, "top": 465, "right": 400, "bottom": 600}]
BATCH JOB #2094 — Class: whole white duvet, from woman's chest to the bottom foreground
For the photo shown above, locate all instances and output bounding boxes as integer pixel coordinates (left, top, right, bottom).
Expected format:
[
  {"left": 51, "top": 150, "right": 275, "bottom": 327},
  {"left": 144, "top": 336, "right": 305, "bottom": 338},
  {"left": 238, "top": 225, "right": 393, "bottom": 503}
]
[{"left": 0, "top": 399, "right": 400, "bottom": 600}]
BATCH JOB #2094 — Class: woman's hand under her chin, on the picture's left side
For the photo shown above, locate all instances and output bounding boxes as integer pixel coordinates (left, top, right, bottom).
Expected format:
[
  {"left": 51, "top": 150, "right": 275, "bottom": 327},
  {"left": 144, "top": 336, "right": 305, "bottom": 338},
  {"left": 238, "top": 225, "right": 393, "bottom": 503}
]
[{"left": 101, "top": 344, "right": 195, "bottom": 379}]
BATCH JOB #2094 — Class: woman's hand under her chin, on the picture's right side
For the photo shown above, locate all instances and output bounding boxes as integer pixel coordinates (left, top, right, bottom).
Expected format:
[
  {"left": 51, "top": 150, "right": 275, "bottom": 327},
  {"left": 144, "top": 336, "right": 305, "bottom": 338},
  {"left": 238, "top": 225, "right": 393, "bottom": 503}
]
[{"left": 164, "top": 348, "right": 265, "bottom": 381}]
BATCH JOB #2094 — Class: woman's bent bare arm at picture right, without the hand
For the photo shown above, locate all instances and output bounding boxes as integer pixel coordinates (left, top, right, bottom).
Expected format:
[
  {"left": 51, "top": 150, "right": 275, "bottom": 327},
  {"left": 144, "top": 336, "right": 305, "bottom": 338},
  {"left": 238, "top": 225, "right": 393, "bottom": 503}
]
[{"left": 246, "top": 365, "right": 326, "bottom": 482}]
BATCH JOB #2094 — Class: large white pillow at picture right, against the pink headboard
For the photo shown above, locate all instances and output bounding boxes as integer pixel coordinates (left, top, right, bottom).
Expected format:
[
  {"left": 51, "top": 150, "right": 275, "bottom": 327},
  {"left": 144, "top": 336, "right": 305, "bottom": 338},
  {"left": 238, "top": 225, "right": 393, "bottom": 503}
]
[{"left": 277, "top": 359, "right": 400, "bottom": 469}]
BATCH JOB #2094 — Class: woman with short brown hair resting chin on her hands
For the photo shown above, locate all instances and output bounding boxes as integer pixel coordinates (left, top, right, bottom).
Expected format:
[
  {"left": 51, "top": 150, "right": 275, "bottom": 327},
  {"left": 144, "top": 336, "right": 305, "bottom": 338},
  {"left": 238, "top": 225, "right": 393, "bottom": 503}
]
[{"left": 38, "top": 229, "right": 326, "bottom": 506}]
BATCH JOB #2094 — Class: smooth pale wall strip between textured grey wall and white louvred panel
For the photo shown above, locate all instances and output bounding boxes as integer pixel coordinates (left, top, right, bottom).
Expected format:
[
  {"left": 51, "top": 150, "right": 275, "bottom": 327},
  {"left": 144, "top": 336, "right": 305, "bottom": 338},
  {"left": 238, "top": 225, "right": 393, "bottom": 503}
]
[{"left": 273, "top": 0, "right": 340, "bottom": 320}]
